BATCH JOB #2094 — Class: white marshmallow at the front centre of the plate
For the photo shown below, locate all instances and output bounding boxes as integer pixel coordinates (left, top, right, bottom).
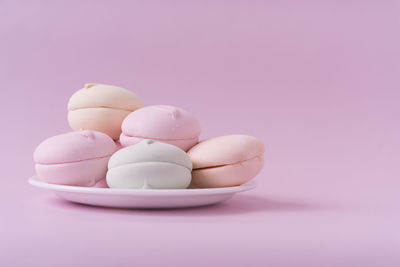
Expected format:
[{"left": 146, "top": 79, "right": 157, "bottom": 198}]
[{"left": 107, "top": 140, "right": 192, "bottom": 189}]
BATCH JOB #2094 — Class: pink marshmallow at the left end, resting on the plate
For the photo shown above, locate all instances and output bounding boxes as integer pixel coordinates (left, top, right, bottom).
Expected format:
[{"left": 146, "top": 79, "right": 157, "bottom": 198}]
[{"left": 33, "top": 131, "right": 116, "bottom": 186}]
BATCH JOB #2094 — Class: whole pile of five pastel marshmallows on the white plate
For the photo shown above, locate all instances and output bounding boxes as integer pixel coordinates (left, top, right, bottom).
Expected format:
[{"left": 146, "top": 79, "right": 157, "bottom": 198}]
[{"left": 34, "top": 83, "right": 264, "bottom": 189}]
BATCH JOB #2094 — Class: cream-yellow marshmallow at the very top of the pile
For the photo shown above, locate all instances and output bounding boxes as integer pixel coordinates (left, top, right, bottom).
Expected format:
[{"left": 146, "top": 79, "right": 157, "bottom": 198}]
[{"left": 68, "top": 83, "right": 144, "bottom": 140}]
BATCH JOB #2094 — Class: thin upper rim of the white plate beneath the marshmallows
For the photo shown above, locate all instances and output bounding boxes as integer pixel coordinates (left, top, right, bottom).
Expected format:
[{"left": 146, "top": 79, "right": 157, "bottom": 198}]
[{"left": 28, "top": 175, "right": 256, "bottom": 196}]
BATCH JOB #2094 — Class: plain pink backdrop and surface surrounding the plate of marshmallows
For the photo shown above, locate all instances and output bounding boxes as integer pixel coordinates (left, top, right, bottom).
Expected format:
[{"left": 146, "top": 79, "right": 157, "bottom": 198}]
[{"left": 0, "top": 0, "right": 400, "bottom": 266}]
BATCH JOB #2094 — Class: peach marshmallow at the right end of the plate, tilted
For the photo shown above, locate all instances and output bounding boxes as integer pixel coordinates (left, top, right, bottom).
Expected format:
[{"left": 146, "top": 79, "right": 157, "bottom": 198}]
[{"left": 188, "top": 135, "right": 265, "bottom": 188}]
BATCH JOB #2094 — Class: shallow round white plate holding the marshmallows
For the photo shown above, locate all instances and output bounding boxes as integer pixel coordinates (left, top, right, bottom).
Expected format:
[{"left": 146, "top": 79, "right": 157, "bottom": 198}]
[{"left": 29, "top": 176, "right": 255, "bottom": 209}]
